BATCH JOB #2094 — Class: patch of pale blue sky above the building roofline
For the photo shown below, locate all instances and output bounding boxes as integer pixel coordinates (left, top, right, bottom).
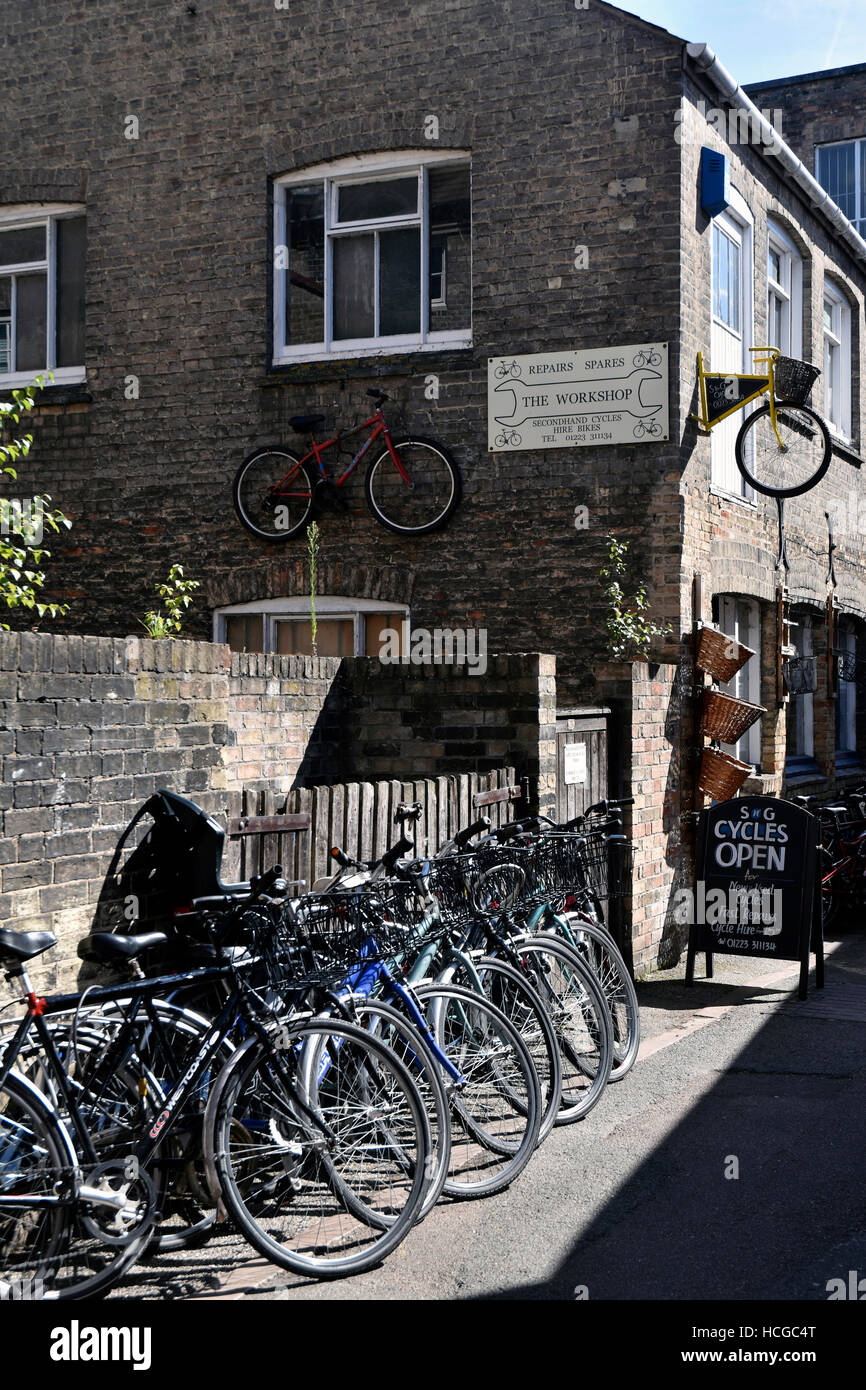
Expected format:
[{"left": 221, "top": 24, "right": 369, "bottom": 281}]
[{"left": 612, "top": 0, "right": 866, "bottom": 86}]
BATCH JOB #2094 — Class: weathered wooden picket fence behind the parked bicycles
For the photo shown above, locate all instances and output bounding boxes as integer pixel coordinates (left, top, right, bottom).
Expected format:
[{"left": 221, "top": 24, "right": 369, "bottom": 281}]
[{"left": 221, "top": 767, "right": 528, "bottom": 891}]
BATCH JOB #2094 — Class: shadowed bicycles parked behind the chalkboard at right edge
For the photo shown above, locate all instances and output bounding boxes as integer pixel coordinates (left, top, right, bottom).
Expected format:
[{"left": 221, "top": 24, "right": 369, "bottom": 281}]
[{"left": 792, "top": 783, "right": 866, "bottom": 930}]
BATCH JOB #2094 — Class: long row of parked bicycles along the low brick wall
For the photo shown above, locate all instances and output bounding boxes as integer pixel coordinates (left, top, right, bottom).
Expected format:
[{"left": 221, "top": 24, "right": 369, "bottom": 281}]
[{"left": 0, "top": 791, "right": 639, "bottom": 1300}]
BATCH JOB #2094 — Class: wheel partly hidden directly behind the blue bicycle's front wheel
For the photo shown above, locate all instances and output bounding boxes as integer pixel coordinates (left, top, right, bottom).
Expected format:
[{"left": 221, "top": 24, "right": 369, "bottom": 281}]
[{"left": 436, "top": 956, "right": 562, "bottom": 1144}]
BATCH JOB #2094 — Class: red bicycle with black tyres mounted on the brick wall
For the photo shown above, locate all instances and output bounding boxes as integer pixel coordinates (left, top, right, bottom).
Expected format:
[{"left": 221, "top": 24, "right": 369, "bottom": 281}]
[{"left": 234, "top": 389, "right": 461, "bottom": 541}]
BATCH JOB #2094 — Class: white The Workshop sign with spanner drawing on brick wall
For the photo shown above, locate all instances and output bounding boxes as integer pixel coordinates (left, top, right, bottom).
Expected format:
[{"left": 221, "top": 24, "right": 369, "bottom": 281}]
[{"left": 487, "top": 343, "right": 669, "bottom": 453}]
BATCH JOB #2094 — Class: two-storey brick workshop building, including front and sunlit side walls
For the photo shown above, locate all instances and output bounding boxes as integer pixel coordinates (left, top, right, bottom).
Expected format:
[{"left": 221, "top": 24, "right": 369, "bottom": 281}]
[{"left": 0, "top": 0, "right": 866, "bottom": 963}]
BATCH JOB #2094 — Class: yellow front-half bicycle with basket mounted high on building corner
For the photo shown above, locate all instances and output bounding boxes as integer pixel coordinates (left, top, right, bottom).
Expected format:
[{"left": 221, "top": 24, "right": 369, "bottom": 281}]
[{"left": 689, "top": 348, "right": 831, "bottom": 498}]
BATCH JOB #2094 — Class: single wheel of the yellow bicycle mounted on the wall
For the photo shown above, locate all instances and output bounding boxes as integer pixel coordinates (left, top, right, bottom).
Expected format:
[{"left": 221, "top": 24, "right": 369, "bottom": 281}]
[{"left": 734, "top": 400, "right": 831, "bottom": 498}]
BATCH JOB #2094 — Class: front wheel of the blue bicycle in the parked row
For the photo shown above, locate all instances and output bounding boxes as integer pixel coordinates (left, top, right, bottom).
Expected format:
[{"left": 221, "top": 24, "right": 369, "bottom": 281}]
[{"left": 414, "top": 984, "right": 541, "bottom": 1197}]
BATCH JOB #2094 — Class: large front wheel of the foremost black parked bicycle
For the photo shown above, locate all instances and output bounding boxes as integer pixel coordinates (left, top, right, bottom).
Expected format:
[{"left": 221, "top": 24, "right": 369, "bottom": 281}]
[{"left": 206, "top": 1017, "right": 430, "bottom": 1279}]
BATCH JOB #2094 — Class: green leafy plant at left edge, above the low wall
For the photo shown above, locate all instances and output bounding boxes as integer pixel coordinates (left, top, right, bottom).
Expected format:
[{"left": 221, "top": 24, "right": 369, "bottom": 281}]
[{"left": 0, "top": 374, "right": 72, "bottom": 632}]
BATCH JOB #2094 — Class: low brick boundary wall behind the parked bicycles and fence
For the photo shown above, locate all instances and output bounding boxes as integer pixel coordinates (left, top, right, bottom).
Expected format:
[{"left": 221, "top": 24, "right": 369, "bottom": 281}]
[{"left": 0, "top": 632, "right": 556, "bottom": 988}]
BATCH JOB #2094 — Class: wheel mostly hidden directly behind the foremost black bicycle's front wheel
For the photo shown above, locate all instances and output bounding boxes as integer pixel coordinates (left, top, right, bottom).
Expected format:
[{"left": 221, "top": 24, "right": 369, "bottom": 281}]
[{"left": 300, "top": 998, "right": 450, "bottom": 1225}]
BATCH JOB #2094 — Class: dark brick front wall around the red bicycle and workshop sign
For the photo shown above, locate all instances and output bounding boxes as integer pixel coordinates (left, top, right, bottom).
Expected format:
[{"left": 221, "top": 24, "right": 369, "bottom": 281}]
[{"left": 0, "top": 0, "right": 692, "bottom": 698}]
